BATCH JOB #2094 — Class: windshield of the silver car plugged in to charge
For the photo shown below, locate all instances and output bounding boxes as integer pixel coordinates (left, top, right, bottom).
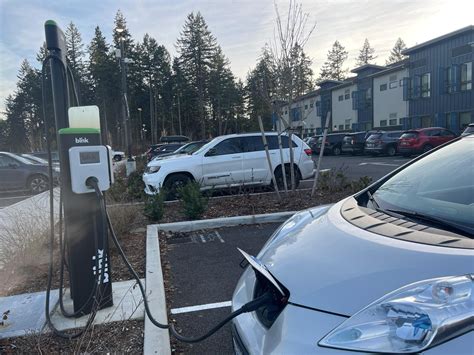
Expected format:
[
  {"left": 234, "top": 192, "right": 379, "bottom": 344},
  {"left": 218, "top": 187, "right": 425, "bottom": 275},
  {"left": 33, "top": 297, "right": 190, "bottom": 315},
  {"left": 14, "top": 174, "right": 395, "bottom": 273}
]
[{"left": 373, "top": 137, "right": 474, "bottom": 228}]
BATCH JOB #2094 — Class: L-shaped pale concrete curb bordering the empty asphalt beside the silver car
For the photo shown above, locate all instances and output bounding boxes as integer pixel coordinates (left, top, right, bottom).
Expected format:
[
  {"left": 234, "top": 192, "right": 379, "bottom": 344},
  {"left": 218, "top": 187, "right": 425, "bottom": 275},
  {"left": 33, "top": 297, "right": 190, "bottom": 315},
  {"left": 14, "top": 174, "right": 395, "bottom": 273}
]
[{"left": 143, "top": 211, "right": 296, "bottom": 355}]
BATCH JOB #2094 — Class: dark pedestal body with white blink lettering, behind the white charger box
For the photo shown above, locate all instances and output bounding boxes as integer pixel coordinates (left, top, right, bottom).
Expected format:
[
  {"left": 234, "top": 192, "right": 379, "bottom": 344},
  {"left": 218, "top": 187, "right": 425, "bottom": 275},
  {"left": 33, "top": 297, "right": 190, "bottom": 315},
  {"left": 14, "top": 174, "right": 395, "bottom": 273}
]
[{"left": 58, "top": 128, "right": 113, "bottom": 314}]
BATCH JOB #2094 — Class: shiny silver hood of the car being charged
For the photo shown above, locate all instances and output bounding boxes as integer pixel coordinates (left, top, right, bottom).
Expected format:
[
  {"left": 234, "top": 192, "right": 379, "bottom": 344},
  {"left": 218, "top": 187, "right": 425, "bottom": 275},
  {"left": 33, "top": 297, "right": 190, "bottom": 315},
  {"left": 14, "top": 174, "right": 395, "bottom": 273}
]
[{"left": 259, "top": 197, "right": 474, "bottom": 315}]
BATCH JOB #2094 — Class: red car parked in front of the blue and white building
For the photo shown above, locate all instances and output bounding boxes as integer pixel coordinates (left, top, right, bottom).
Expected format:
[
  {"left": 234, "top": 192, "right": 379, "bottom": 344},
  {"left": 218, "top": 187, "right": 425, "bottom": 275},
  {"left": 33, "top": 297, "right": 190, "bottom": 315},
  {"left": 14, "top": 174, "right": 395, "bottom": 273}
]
[{"left": 398, "top": 127, "right": 456, "bottom": 157}]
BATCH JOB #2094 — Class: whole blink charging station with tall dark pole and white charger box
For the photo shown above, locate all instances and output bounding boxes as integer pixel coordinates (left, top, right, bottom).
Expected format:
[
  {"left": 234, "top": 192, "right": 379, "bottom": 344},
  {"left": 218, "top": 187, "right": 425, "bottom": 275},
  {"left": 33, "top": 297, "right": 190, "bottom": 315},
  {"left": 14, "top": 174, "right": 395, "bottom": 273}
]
[{"left": 45, "top": 21, "right": 113, "bottom": 317}]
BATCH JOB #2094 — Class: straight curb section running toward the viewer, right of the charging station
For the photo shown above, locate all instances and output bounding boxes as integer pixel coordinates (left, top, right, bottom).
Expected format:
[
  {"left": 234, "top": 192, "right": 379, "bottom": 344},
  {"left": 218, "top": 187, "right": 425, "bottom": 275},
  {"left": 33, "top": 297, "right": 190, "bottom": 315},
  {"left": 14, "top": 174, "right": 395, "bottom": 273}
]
[{"left": 143, "top": 225, "right": 171, "bottom": 355}]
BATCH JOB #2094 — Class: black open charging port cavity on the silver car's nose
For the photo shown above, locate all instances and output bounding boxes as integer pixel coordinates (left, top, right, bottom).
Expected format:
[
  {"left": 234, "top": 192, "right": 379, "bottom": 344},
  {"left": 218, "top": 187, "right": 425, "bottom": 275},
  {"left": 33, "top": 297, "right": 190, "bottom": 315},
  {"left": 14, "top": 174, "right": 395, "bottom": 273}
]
[{"left": 254, "top": 272, "right": 289, "bottom": 328}]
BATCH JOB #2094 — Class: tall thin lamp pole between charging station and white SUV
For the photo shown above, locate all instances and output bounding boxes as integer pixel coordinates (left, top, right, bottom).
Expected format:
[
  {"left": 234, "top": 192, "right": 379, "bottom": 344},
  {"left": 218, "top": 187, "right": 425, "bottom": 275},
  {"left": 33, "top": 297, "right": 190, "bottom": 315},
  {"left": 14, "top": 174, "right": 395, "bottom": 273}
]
[{"left": 115, "top": 28, "right": 136, "bottom": 176}]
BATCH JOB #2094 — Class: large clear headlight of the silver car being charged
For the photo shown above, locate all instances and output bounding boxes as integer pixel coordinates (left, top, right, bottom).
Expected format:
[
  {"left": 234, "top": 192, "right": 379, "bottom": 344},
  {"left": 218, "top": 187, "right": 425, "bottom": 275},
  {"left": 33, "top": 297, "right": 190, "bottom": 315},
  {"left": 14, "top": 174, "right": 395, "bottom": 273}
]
[{"left": 319, "top": 274, "right": 474, "bottom": 353}]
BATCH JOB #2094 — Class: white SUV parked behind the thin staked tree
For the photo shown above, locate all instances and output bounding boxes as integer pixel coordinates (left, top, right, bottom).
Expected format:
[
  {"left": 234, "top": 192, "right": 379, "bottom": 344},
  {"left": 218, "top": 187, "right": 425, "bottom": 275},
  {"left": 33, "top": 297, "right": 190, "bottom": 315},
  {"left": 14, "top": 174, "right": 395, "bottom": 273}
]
[{"left": 143, "top": 132, "right": 314, "bottom": 195}]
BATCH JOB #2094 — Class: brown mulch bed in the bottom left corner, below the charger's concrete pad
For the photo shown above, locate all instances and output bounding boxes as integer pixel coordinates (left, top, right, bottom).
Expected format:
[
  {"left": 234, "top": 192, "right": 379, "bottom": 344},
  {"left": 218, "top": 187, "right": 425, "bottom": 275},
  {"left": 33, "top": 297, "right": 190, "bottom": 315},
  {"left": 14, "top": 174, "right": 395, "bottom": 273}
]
[{"left": 0, "top": 320, "right": 144, "bottom": 354}]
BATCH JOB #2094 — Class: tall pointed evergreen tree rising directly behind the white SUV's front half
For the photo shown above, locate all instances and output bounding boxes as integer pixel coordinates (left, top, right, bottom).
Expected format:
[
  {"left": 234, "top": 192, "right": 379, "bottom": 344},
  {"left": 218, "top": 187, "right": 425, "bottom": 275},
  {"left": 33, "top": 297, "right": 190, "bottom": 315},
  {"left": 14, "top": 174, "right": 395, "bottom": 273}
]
[{"left": 177, "top": 12, "right": 216, "bottom": 138}]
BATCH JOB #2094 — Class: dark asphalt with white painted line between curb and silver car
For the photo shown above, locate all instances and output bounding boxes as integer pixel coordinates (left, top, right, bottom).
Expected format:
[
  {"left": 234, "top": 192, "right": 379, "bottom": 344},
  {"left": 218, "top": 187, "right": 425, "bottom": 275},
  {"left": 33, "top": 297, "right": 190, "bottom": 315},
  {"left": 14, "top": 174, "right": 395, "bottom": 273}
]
[{"left": 167, "top": 223, "right": 279, "bottom": 354}]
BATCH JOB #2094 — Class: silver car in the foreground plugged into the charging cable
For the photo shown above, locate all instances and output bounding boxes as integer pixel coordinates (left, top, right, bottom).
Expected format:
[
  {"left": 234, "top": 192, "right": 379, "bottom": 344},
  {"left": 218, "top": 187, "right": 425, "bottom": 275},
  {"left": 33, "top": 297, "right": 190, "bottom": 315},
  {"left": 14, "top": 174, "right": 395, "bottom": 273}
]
[{"left": 232, "top": 135, "right": 474, "bottom": 355}]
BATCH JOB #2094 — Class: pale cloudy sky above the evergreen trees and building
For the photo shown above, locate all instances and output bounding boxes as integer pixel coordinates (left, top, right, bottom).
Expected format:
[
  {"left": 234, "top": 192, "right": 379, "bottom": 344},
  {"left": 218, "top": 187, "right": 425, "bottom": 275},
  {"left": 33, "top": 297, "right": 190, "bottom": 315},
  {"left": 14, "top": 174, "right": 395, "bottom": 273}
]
[{"left": 0, "top": 0, "right": 474, "bottom": 118}]
